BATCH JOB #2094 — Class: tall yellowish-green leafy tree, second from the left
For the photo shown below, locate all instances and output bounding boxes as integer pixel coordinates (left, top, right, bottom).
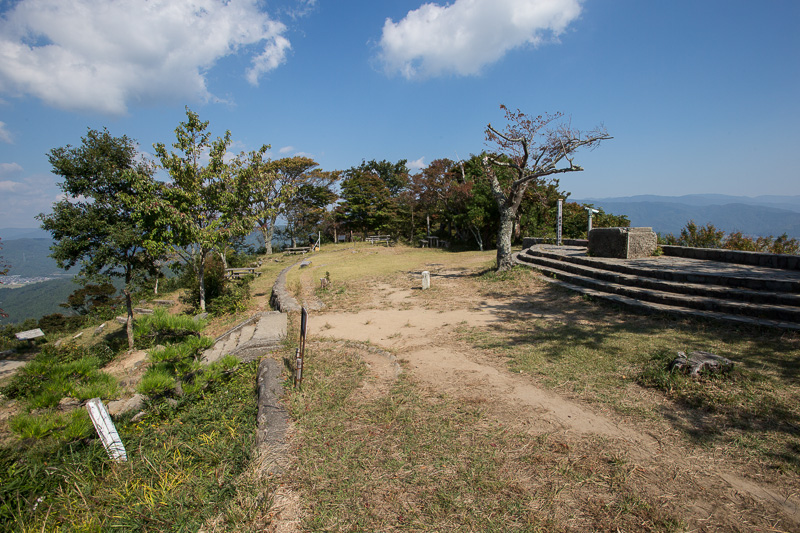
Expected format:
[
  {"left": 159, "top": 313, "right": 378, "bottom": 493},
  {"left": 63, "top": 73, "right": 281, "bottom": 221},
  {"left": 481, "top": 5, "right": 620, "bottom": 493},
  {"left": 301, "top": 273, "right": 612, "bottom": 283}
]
[{"left": 149, "top": 107, "right": 254, "bottom": 311}]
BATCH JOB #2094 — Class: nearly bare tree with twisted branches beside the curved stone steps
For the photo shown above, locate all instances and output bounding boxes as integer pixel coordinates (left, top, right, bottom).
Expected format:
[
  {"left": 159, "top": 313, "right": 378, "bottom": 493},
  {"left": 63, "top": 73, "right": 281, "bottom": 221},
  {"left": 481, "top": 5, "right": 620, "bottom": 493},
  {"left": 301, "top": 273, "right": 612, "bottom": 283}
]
[{"left": 483, "top": 105, "right": 612, "bottom": 272}]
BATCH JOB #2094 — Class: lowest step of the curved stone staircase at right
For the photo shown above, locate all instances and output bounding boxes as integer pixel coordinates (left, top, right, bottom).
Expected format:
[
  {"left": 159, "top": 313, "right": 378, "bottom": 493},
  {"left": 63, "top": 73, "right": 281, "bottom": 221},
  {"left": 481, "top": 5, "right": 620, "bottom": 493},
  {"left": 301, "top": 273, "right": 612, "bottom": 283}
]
[{"left": 516, "top": 254, "right": 800, "bottom": 329}]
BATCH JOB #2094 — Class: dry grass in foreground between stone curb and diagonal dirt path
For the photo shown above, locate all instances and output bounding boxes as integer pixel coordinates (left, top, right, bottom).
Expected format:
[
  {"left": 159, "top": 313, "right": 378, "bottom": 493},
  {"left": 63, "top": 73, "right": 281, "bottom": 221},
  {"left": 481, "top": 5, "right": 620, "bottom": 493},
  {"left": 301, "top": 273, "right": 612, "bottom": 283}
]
[{"left": 282, "top": 342, "right": 680, "bottom": 531}]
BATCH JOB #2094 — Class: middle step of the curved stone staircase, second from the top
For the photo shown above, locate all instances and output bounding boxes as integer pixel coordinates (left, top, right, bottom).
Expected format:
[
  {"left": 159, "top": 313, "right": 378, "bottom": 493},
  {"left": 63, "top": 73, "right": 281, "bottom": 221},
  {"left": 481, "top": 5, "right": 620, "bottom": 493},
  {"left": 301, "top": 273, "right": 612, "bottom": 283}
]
[{"left": 518, "top": 254, "right": 800, "bottom": 307}]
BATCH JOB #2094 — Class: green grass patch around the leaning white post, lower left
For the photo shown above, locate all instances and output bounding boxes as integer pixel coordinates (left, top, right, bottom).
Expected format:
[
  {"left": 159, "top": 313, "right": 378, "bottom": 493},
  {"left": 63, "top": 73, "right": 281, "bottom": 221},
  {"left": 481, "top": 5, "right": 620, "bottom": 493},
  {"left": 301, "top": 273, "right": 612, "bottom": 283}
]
[{"left": 0, "top": 362, "right": 270, "bottom": 531}]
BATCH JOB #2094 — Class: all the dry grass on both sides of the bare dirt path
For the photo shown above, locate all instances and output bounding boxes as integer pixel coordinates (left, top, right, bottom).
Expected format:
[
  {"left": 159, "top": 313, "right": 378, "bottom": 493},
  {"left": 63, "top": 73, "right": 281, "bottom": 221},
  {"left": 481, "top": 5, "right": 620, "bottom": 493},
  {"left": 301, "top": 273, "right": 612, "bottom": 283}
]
[{"left": 280, "top": 252, "right": 800, "bottom": 531}]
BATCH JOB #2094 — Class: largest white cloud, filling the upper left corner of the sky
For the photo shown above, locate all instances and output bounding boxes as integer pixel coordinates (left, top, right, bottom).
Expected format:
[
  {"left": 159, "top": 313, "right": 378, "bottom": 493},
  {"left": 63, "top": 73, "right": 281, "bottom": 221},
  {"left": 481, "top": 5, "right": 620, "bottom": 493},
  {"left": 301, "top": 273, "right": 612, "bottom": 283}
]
[{"left": 0, "top": 0, "right": 291, "bottom": 114}]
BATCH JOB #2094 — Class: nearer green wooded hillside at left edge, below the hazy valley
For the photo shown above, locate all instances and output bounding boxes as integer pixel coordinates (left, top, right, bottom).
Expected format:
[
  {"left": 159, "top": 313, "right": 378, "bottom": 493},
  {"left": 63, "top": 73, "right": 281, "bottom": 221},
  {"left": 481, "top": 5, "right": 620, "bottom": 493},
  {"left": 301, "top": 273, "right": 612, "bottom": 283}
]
[{"left": 0, "top": 278, "right": 79, "bottom": 325}]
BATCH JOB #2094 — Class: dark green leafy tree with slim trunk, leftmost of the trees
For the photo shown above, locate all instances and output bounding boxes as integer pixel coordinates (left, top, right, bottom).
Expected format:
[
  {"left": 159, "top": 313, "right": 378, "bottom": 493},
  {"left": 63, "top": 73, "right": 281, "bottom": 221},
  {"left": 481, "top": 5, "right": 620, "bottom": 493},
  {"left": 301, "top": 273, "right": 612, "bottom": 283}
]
[{"left": 36, "top": 129, "right": 162, "bottom": 348}]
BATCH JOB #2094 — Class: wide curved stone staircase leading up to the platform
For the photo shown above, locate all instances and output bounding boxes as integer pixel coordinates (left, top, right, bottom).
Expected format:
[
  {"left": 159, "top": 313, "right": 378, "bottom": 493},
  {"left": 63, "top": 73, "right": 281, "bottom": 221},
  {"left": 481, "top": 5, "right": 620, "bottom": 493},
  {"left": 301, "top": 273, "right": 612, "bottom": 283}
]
[{"left": 515, "top": 245, "right": 800, "bottom": 330}]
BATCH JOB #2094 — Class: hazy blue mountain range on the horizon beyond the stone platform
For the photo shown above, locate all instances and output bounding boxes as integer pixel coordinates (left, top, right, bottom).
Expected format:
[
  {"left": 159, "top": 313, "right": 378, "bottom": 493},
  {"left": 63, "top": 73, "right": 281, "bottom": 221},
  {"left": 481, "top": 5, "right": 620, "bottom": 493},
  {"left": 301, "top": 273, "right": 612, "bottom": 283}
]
[{"left": 568, "top": 194, "right": 800, "bottom": 238}]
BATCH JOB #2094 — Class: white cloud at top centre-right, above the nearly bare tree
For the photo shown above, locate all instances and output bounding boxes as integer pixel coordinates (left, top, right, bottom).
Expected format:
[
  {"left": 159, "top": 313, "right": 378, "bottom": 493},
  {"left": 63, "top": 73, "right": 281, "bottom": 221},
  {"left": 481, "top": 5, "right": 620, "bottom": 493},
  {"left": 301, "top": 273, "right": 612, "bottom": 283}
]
[{"left": 380, "top": 0, "right": 583, "bottom": 79}]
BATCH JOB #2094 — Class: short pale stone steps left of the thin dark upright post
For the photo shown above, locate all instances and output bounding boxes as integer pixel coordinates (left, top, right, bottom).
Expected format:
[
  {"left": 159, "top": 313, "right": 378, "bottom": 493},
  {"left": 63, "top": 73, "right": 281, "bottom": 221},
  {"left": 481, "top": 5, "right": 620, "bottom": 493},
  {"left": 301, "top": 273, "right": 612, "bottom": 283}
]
[{"left": 203, "top": 311, "right": 287, "bottom": 363}]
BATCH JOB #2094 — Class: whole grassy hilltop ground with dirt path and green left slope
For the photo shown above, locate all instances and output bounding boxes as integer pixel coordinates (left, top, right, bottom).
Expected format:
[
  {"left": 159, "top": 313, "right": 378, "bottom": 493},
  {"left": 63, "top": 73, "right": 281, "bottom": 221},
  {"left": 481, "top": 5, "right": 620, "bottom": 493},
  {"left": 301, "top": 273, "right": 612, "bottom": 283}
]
[{"left": 0, "top": 244, "right": 800, "bottom": 531}]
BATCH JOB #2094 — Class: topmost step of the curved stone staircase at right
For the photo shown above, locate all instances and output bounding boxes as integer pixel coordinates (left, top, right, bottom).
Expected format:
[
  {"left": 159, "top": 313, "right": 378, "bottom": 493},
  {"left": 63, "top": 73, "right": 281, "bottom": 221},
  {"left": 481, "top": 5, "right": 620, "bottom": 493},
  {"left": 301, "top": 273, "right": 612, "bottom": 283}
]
[{"left": 524, "top": 248, "right": 800, "bottom": 293}]
